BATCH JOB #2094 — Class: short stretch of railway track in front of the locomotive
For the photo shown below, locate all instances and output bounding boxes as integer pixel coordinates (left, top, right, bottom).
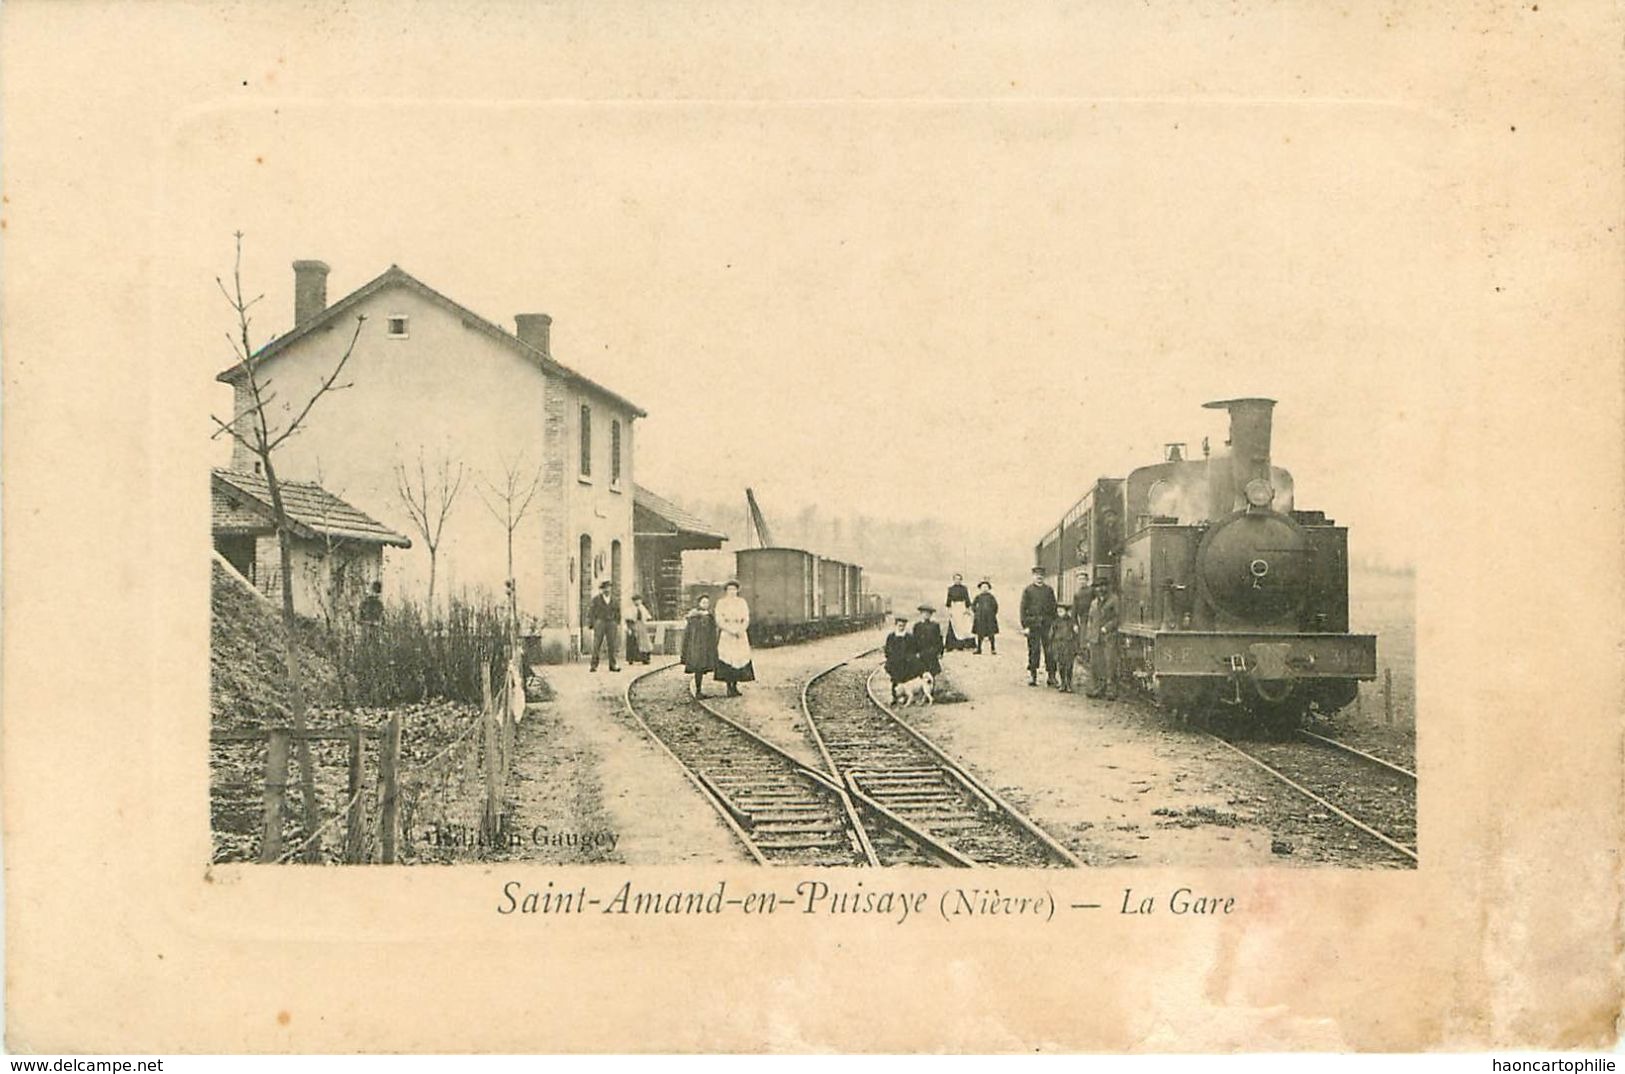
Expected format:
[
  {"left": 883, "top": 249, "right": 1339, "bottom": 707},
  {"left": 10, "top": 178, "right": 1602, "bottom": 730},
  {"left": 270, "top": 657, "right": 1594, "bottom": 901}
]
[{"left": 1206, "top": 731, "right": 1420, "bottom": 863}]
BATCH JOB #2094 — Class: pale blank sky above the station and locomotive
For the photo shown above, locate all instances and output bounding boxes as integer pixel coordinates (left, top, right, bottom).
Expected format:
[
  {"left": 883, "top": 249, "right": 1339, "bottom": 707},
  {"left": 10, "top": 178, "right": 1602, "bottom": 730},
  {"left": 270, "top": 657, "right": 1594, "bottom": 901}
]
[{"left": 181, "top": 93, "right": 1462, "bottom": 564}]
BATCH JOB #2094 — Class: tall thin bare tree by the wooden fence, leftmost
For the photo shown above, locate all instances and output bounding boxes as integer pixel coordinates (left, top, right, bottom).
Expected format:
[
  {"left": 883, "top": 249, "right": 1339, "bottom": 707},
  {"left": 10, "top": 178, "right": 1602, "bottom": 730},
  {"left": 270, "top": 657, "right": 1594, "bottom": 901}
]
[{"left": 210, "top": 231, "right": 366, "bottom": 861}]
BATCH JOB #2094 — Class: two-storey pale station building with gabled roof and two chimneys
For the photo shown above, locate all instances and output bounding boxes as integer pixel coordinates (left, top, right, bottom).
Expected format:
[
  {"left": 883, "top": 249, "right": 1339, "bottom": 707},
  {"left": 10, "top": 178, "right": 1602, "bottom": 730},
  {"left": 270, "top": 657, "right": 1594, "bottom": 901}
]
[{"left": 216, "top": 260, "right": 710, "bottom": 652}]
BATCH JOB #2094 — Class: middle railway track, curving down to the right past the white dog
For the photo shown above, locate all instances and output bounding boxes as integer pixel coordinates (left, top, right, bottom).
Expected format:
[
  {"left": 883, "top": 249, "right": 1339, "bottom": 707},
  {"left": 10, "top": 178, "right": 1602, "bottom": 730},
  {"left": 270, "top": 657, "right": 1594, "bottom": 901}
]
[{"left": 801, "top": 650, "right": 1079, "bottom": 866}]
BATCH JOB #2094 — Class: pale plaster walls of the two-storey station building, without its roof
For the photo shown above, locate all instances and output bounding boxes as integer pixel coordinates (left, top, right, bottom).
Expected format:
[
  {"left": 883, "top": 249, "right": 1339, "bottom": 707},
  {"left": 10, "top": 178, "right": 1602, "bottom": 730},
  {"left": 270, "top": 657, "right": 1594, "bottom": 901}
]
[{"left": 222, "top": 288, "right": 632, "bottom": 626}]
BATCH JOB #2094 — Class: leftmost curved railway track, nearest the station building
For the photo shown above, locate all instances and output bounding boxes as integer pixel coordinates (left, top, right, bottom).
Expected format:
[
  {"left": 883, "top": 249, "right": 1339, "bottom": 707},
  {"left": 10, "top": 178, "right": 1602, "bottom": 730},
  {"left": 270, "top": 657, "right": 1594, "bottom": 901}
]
[{"left": 626, "top": 665, "right": 960, "bottom": 866}]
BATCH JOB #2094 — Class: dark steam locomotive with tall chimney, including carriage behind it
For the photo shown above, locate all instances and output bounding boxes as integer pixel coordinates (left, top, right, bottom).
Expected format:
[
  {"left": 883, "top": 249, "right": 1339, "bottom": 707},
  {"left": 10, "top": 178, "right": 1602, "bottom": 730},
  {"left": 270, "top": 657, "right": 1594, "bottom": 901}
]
[{"left": 1037, "top": 398, "right": 1376, "bottom": 726}]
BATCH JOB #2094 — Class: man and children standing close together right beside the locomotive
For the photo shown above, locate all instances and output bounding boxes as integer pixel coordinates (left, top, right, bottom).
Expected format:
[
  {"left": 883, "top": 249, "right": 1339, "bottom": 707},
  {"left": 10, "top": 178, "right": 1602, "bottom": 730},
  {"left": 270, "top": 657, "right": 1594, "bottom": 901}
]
[{"left": 1021, "top": 567, "right": 1118, "bottom": 700}]
